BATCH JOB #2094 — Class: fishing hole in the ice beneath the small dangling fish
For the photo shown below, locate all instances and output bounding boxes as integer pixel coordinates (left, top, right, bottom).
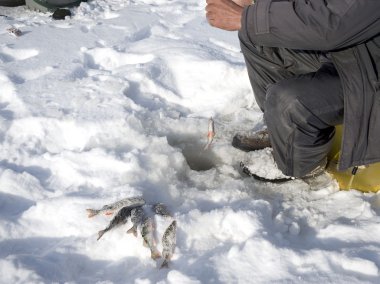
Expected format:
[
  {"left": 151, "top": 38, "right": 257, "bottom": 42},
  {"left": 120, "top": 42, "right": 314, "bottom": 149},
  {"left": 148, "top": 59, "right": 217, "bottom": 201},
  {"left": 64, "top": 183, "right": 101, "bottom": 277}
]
[{"left": 167, "top": 135, "right": 218, "bottom": 171}]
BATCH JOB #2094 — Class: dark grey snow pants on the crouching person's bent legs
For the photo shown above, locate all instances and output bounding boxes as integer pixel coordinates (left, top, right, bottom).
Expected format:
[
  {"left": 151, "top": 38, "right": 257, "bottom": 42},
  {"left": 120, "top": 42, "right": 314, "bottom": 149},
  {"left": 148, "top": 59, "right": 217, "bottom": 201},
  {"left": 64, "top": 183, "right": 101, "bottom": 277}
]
[{"left": 239, "top": 33, "right": 343, "bottom": 177}]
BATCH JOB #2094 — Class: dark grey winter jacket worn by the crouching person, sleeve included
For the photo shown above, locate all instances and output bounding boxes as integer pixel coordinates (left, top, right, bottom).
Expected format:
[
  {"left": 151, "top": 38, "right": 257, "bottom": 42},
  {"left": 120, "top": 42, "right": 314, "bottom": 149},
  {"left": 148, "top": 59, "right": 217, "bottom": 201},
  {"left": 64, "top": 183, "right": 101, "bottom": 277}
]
[{"left": 240, "top": 0, "right": 380, "bottom": 170}]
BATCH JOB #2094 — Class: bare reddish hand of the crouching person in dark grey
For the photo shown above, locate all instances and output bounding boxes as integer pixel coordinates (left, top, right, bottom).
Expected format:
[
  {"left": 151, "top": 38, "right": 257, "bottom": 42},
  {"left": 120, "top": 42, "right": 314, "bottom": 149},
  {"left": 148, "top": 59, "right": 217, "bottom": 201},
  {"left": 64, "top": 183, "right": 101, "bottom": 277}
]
[{"left": 206, "top": 0, "right": 246, "bottom": 31}]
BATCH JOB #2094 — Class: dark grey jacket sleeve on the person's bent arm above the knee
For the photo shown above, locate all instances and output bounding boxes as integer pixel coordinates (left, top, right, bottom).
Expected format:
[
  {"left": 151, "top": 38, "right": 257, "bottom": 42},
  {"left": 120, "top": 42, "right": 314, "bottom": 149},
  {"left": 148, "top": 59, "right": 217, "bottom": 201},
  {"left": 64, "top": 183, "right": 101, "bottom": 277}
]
[{"left": 240, "top": 0, "right": 380, "bottom": 51}]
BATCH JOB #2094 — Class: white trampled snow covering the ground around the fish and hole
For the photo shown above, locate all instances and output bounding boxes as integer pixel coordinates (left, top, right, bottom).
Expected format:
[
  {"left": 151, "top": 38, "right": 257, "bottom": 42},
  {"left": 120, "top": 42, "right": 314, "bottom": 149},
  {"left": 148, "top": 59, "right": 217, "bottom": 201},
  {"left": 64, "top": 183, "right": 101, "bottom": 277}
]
[{"left": 0, "top": 0, "right": 380, "bottom": 284}]
